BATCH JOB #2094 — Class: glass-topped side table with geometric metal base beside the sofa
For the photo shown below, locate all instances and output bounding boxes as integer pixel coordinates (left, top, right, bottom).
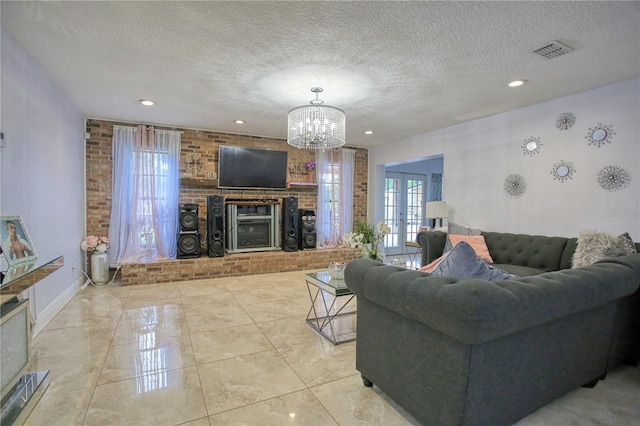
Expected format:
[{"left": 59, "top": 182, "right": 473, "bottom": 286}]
[{"left": 304, "top": 271, "right": 356, "bottom": 345}]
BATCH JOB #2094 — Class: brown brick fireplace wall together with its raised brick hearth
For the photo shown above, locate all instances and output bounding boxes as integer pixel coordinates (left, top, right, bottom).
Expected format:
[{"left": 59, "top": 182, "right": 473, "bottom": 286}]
[{"left": 86, "top": 119, "right": 368, "bottom": 285}]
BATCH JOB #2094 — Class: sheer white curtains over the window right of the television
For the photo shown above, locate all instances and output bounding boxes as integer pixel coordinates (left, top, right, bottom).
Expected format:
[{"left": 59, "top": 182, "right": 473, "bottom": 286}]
[{"left": 316, "top": 148, "right": 355, "bottom": 247}]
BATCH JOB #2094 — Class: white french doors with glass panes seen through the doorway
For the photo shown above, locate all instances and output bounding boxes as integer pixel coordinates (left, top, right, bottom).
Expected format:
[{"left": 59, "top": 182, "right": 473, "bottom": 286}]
[{"left": 384, "top": 172, "right": 426, "bottom": 255}]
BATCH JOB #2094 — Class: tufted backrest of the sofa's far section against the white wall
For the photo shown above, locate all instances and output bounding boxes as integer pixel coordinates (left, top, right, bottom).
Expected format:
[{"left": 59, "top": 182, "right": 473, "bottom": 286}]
[{"left": 482, "top": 232, "right": 577, "bottom": 271}]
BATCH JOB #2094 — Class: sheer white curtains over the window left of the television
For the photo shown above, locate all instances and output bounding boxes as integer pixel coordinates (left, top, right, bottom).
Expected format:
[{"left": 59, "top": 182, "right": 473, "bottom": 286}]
[{"left": 109, "top": 126, "right": 181, "bottom": 267}]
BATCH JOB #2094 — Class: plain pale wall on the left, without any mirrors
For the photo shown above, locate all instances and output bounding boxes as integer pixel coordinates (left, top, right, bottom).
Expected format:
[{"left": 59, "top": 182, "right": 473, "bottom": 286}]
[{"left": 0, "top": 31, "right": 85, "bottom": 333}]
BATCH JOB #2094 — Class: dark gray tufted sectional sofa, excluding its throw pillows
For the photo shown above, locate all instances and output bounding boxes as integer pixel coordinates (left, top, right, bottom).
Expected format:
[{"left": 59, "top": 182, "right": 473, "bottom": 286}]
[{"left": 345, "top": 233, "right": 640, "bottom": 426}]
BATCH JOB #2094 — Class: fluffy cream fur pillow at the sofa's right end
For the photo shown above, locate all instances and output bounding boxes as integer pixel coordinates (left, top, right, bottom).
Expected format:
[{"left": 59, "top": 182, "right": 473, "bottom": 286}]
[{"left": 572, "top": 230, "right": 636, "bottom": 268}]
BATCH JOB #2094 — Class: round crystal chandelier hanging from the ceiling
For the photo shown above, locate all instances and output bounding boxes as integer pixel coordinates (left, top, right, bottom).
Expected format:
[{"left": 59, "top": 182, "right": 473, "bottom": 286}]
[{"left": 287, "top": 87, "right": 346, "bottom": 150}]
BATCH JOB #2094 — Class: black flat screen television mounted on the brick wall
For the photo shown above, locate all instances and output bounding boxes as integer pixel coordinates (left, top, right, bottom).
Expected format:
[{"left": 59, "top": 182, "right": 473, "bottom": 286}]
[{"left": 218, "top": 145, "right": 288, "bottom": 189}]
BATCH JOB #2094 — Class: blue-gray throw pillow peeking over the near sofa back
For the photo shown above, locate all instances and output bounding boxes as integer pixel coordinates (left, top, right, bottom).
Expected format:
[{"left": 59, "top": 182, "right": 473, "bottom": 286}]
[{"left": 431, "top": 241, "right": 520, "bottom": 281}]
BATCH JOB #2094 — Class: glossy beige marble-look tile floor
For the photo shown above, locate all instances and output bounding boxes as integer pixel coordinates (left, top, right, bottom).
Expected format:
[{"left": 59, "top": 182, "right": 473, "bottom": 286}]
[{"left": 26, "top": 272, "right": 640, "bottom": 426}]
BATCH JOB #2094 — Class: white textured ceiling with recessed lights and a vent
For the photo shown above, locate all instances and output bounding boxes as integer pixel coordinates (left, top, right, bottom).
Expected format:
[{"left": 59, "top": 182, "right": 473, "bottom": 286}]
[{"left": 0, "top": 0, "right": 640, "bottom": 147}]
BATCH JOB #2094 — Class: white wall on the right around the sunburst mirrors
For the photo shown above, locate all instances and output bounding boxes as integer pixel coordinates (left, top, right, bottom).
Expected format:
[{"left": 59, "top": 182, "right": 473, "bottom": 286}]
[{"left": 369, "top": 79, "right": 640, "bottom": 241}]
